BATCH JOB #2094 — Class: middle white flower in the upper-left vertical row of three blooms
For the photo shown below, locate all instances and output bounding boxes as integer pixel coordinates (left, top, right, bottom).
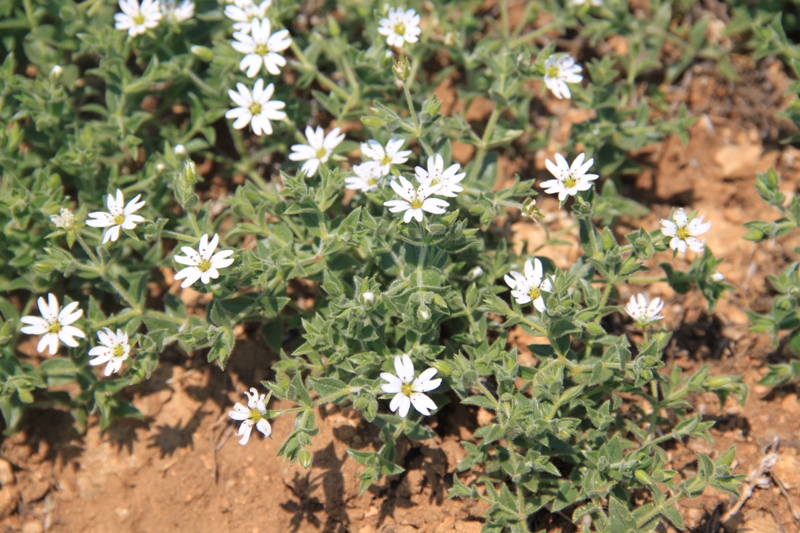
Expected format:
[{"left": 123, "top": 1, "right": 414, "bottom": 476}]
[{"left": 231, "top": 19, "right": 292, "bottom": 78}]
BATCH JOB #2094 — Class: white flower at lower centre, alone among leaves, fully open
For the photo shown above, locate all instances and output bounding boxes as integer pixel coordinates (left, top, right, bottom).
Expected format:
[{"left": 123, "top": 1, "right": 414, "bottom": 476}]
[{"left": 381, "top": 354, "right": 442, "bottom": 418}]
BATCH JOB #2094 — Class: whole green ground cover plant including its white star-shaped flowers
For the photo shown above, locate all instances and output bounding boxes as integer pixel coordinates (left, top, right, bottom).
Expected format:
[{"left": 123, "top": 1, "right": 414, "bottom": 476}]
[{"left": 0, "top": 0, "right": 797, "bottom": 532}]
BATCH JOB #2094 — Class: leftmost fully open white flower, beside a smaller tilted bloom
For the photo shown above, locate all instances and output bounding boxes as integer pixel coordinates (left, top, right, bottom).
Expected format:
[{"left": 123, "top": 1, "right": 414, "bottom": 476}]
[{"left": 19, "top": 293, "right": 86, "bottom": 355}]
